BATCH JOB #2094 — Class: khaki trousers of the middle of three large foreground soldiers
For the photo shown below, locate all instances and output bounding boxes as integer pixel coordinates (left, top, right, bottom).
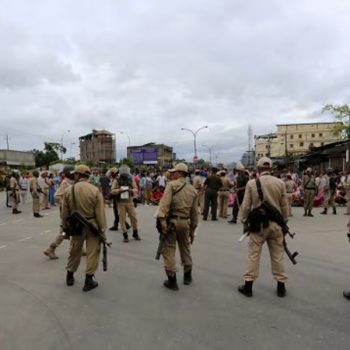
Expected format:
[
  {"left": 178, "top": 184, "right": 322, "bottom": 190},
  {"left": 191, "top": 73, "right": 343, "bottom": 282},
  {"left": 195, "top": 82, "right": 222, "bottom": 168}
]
[{"left": 162, "top": 220, "right": 192, "bottom": 274}]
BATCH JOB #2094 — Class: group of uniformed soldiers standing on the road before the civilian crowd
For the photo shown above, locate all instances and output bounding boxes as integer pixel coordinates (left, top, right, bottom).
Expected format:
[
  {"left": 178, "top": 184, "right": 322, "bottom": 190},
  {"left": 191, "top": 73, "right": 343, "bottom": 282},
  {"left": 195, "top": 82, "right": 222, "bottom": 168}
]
[{"left": 4, "top": 157, "right": 350, "bottom": 299}]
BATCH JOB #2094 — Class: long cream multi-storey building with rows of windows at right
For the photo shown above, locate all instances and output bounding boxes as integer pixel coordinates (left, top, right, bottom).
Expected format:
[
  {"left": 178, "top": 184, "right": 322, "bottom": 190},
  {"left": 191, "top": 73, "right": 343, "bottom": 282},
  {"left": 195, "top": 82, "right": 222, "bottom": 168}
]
[{"left": 255, "top": 122, "right": 340, "bottom": 159}]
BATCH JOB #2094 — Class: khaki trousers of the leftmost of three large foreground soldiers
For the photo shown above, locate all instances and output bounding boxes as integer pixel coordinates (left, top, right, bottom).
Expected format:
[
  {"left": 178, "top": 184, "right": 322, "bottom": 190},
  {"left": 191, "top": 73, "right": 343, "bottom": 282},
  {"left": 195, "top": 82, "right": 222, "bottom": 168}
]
[{"left": 66, "top": 231, "right": 101, "bottom": 275}]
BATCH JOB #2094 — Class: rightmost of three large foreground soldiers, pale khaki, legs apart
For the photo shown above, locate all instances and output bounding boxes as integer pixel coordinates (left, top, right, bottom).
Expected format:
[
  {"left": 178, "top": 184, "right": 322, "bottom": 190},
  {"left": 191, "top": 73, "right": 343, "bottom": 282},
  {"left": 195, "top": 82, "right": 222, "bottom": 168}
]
[{"left": 238, "top": 157, "right": 288, "bottom": 297}]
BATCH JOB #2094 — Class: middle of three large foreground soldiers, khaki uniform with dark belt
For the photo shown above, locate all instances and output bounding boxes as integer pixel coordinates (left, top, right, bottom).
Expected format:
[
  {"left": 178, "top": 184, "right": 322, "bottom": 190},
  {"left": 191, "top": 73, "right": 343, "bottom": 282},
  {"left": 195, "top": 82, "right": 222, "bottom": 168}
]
[{"left": 158, "top": 163, "right": 198, "bottom": 290}]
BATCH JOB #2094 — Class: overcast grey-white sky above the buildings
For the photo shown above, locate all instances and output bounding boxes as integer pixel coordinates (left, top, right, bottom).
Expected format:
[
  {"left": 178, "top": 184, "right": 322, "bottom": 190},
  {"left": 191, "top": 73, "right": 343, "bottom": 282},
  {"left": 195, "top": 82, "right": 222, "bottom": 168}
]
[{"left": 0, "top": 0, "right": 350, "bottom": 162}]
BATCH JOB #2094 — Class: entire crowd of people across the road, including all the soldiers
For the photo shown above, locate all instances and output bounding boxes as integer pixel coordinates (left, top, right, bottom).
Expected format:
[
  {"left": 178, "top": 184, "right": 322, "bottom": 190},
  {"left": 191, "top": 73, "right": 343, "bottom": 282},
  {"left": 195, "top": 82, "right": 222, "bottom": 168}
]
[{"left": 7, "top": 158, "right": 350, "bottom": 298}]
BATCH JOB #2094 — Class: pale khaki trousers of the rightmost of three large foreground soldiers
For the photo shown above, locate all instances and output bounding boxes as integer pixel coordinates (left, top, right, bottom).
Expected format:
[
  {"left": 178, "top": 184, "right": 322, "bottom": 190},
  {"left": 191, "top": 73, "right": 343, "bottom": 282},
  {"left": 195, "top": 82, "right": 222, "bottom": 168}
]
[{"left": 244, "top": 222, "right": 287, "bottom": 283}]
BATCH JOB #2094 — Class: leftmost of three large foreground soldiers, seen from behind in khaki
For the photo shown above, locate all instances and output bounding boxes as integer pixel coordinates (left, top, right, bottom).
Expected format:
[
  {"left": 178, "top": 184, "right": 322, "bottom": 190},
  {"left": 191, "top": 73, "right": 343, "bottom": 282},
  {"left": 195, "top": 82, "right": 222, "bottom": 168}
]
[{"left": 62, "top": 165, "right": 106, "bottom": 292}]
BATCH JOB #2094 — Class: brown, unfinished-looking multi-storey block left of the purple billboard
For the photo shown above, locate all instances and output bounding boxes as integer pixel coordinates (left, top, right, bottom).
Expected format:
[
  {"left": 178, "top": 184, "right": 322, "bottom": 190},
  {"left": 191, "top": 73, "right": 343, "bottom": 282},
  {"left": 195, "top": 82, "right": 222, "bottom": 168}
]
[{"left": 79, "top": 129, "right": 116, "bottom": 163}]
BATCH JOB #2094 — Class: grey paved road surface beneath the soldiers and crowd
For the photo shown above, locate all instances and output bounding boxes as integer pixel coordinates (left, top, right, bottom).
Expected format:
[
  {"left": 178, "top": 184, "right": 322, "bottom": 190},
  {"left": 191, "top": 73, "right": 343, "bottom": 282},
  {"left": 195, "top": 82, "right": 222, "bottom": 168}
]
[{"left": 0, "top": 193, "right": 350, "bottom": 350}]
